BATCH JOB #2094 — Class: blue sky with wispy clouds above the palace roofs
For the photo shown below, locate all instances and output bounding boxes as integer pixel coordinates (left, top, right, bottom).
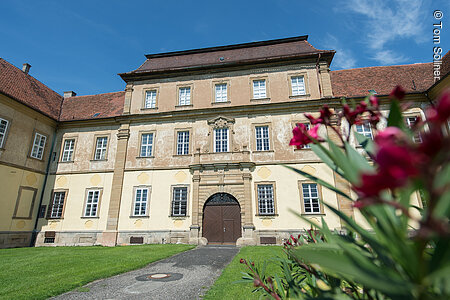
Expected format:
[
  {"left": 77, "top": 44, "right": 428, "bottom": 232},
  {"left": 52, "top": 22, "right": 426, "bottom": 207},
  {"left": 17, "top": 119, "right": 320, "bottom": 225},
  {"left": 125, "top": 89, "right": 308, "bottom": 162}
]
[{"left": 0, "top": 0, "right": 450, "bottom": 95}]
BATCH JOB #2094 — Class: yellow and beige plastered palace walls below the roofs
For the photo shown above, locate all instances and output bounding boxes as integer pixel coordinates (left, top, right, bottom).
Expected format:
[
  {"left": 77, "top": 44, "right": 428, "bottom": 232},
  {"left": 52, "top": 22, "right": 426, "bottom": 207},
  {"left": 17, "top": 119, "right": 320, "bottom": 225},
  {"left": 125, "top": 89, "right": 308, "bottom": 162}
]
[{"left": 0, "top": 38, "right": 436, "bottom": 247}]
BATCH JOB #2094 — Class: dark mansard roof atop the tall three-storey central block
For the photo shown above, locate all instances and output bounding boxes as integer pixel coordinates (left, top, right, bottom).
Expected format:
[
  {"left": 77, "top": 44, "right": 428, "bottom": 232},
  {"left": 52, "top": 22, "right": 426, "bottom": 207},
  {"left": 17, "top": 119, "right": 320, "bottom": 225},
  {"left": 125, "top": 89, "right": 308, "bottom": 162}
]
[{"left": 119, "top": 36, "right": 335, "bottom": 79}]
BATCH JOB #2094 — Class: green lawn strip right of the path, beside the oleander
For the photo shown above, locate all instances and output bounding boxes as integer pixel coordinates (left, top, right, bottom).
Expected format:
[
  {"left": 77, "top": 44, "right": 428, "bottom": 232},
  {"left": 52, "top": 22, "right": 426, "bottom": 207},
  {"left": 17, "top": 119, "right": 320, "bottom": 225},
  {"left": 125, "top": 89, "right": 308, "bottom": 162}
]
[{"left": 204, "top": 246, "right": 285, "bottom": 300}]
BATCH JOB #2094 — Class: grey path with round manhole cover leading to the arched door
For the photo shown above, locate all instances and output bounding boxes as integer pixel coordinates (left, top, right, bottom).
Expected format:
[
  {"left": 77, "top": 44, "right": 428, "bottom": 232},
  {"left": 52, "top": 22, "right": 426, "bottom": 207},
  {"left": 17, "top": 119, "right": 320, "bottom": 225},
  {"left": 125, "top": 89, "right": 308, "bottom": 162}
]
[{"left": 53, "top": 246, "right": 239, "bottom": 299}]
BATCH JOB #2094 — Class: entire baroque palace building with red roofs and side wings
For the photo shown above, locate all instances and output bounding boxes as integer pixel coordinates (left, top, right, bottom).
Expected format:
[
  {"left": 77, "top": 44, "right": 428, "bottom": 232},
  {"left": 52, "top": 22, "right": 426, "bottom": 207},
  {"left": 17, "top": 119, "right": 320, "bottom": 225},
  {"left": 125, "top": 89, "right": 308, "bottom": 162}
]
[{"left": 0, "top": 36, "right": 450, "bottom": 248}]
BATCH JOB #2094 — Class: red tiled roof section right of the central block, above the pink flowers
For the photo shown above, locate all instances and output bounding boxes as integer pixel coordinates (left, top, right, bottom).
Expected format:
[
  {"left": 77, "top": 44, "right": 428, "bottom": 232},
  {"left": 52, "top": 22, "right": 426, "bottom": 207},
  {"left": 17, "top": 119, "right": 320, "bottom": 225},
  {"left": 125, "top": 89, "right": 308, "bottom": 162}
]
[{"left": 330, "top": 63, "right": 434, "bottom": 97}]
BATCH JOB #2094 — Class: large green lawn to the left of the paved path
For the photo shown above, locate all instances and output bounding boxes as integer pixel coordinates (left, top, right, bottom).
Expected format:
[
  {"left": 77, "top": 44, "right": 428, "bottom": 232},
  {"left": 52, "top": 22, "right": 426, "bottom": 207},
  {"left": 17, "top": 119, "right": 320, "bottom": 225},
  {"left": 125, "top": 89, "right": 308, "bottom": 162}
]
[{"left": 0, "top": 245, "right": 194, "bottom": 299}]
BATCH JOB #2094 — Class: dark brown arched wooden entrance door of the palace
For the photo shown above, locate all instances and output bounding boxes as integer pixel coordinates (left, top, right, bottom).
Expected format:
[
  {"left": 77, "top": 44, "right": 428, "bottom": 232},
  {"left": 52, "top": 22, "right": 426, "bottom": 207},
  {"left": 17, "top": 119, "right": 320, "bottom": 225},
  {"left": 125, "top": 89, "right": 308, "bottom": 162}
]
[{"left": 203, "top": 193, "right": 241, "bottom": 244}]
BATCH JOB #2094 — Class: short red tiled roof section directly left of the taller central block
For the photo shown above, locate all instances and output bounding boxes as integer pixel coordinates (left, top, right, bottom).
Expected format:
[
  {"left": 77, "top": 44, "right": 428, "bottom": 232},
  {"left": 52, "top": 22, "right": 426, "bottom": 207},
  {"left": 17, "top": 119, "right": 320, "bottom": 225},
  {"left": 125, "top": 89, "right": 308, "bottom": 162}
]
[{"left": 59, "top": 92, "right": 125, "bottom": 121}]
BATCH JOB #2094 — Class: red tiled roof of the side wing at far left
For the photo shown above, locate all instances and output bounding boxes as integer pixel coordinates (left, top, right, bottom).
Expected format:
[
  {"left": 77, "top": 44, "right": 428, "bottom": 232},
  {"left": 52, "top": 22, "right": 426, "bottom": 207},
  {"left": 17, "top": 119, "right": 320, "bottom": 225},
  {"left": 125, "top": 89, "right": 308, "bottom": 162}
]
[{"left": 0, "top": 58, "right": 63, "bottom": 120}]
